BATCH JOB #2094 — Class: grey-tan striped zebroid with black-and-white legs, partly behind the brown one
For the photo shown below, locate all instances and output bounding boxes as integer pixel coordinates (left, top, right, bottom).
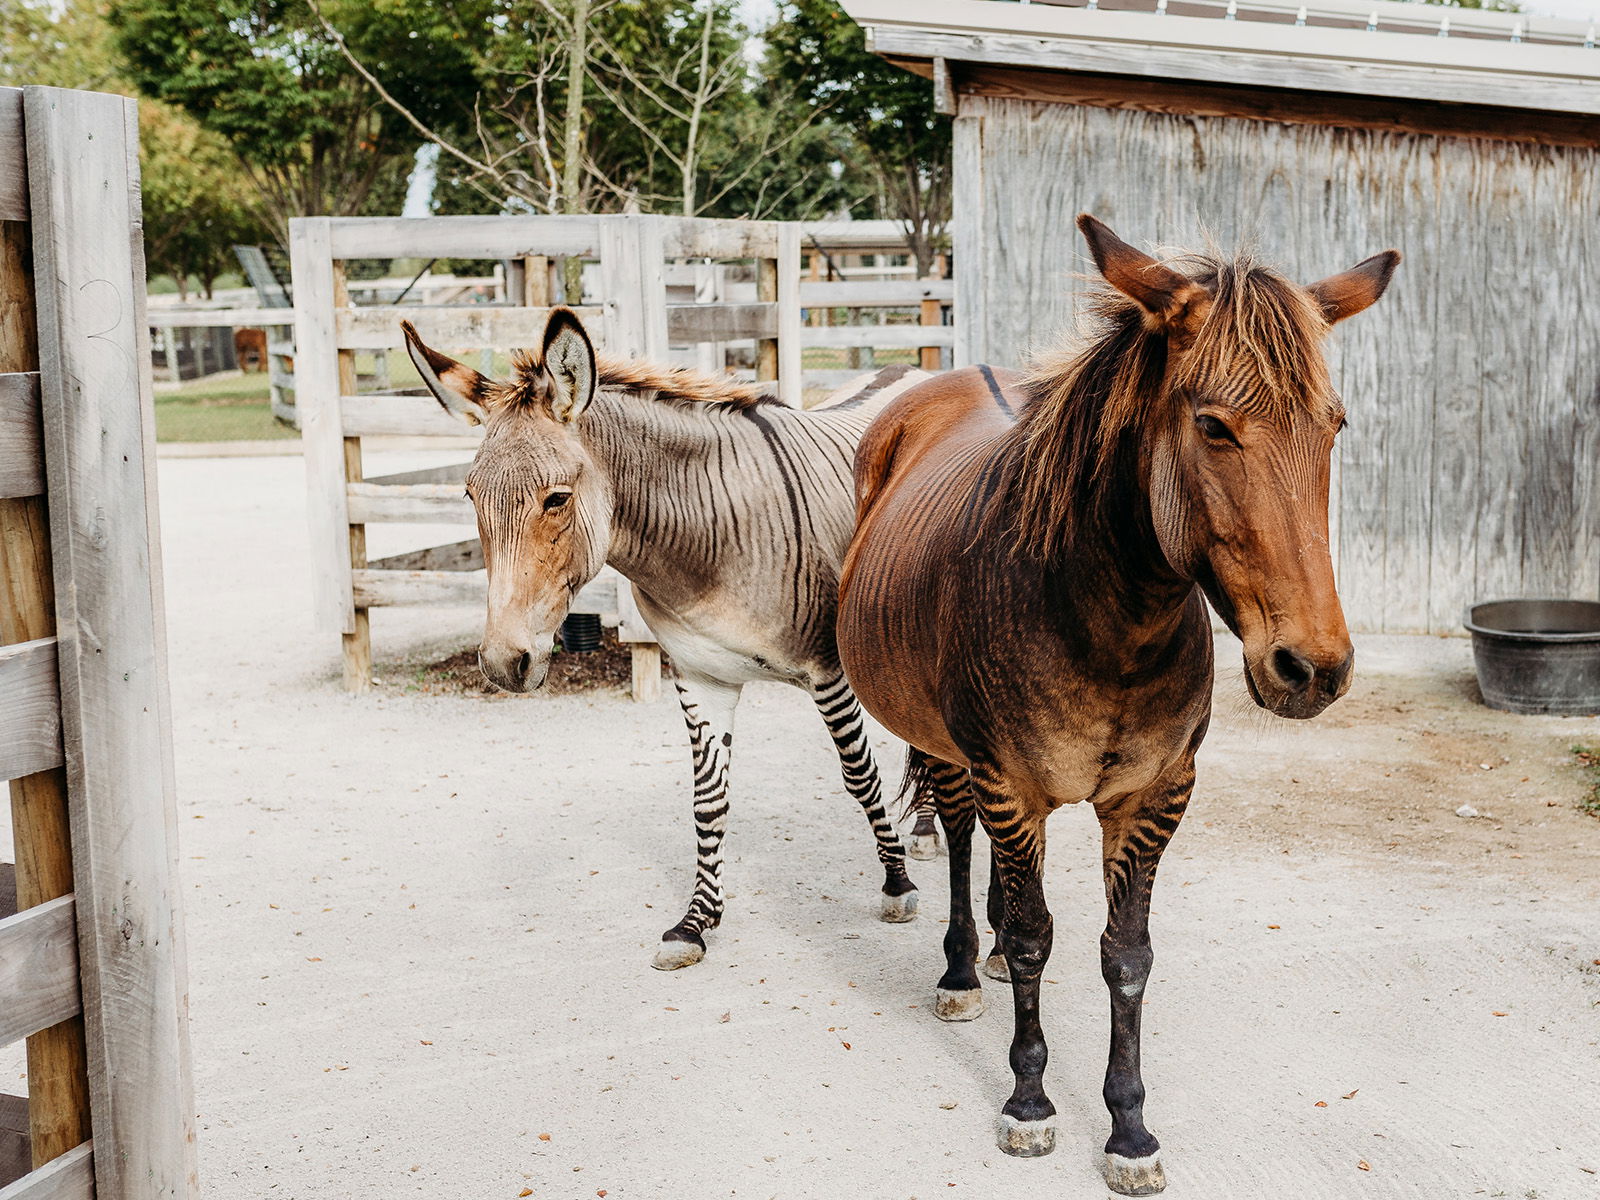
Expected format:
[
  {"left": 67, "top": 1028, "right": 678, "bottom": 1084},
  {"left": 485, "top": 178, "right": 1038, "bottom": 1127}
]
[{"left": 405, "top": 309, "right": 926, "bottom": 970}]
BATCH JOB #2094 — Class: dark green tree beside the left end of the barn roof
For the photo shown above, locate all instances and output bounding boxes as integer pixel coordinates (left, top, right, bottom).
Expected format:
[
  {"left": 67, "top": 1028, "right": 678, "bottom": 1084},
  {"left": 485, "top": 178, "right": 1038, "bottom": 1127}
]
[{"left": 766, "top": 0, "right": 950, "bottom": 275}]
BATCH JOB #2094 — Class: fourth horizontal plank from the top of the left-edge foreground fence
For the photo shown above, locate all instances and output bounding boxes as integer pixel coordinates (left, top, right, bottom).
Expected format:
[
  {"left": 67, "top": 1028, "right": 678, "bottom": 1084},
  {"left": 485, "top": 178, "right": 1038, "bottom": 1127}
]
[{"left": 0, "top": 896, "right": 82, "bottom": 1046}]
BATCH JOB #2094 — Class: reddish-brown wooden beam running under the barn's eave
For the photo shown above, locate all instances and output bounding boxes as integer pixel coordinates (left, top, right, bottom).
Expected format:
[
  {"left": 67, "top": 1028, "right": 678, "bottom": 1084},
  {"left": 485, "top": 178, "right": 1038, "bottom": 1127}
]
[{"left": 960, "top": 66, "right": 1600, "bottom": 147}]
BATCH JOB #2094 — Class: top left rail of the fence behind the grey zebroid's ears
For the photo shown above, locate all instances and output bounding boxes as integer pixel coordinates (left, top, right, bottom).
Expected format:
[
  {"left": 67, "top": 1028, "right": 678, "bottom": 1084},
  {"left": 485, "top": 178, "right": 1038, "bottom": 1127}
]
[{"left": 328, "top": 216, "right": 608, "bottom": 262}]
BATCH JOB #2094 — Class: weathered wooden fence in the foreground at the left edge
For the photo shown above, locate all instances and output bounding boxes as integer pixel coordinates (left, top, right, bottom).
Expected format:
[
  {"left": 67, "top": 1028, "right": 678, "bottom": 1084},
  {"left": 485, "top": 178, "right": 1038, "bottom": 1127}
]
[{"left": 0, "top": 88, "right": 197, "bottom": 1200}]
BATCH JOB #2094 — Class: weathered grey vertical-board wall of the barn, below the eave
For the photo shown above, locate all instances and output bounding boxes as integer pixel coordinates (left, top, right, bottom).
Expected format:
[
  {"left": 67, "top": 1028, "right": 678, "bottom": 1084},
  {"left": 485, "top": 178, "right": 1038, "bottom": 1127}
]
[{"left": 955, "top": 96, "right": 1600, "bottom": 632}]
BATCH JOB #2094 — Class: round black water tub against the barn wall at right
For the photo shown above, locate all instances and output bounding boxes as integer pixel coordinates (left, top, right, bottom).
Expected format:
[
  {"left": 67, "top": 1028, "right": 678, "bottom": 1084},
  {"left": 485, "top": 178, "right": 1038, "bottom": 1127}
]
[{"left": 1466, "top": 600, "right": 1600, "bottom": 717}]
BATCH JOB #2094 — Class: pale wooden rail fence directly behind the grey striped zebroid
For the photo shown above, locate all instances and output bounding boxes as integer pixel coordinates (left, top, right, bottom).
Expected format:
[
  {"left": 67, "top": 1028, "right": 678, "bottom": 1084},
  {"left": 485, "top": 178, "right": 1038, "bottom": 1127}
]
[{"left": 290, "top": 216, "right": 802, "bottom": 701}]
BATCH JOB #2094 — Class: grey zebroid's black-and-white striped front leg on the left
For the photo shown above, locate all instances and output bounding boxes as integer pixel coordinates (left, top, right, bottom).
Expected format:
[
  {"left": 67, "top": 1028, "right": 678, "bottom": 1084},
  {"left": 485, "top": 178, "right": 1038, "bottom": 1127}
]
[{"left": 653, "top": 678, "right": 742, "bottom": 971}]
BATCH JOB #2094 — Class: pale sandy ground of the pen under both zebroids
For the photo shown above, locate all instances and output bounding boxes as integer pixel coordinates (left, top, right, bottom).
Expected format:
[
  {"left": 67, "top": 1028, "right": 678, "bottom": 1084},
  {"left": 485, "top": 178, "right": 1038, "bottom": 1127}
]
[{"left": 12, "top": 454, "right": 1600, "bottom": 1200}]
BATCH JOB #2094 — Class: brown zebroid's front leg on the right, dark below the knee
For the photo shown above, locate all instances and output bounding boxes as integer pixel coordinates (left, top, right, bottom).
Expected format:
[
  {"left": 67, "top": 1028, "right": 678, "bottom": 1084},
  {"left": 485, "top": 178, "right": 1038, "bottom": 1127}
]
[{"left": 1099, "top": 765, "right": 1194, "bottom": 1195}]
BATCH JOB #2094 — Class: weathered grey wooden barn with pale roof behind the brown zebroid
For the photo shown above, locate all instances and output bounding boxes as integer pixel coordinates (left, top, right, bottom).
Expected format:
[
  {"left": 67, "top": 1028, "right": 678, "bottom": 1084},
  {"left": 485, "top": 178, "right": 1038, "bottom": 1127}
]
[{"left": 843, "top": 0, "right": 1600, "bottom": 632}]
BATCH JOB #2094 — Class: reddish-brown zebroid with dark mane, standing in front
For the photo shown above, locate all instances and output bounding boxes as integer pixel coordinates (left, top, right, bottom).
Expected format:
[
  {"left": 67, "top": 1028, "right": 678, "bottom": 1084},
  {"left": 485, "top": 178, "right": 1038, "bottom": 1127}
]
[{"left": 838, "top": 216, "right": 1400, "bottom": 1195}]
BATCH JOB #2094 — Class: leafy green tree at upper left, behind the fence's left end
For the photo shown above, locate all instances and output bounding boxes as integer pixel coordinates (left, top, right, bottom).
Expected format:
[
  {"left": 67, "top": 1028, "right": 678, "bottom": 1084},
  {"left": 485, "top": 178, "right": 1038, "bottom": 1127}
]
[{"left": 109, "top": 0, "right": 464, "bottom": 242}]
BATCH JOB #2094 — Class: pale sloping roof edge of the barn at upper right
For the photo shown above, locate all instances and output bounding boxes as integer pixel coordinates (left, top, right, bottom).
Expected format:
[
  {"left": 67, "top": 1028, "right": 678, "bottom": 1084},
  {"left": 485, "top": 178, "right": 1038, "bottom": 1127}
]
[{"left": 843, "top": 0, "right": 1600, "bottom": 115}]
